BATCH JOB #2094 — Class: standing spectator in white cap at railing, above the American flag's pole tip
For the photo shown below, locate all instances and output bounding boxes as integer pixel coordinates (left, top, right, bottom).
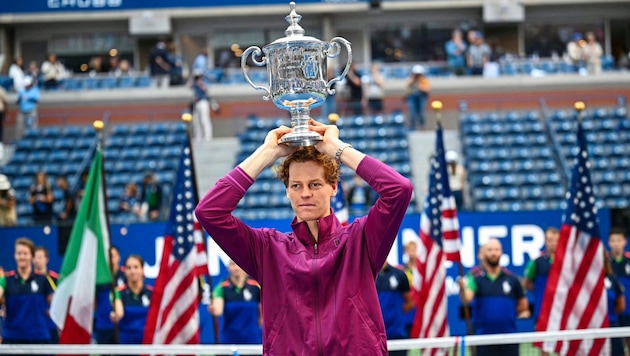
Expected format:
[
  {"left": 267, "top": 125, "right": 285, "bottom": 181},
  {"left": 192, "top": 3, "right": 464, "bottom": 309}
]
[{"left": 405, "top": 64, "right": 431, "bottom": 131}]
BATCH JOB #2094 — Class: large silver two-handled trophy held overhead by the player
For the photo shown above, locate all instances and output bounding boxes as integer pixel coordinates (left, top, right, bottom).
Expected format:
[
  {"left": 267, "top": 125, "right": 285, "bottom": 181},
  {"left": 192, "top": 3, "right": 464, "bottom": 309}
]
[{"left": 241, "top": 2, "right": 352, "bottom": 146}]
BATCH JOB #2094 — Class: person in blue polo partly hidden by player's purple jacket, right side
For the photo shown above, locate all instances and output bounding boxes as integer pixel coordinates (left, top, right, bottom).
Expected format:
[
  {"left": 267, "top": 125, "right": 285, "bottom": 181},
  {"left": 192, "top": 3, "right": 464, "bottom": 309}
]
[{"left": 376, "top": 261, "right": 414, "bottom": 356}]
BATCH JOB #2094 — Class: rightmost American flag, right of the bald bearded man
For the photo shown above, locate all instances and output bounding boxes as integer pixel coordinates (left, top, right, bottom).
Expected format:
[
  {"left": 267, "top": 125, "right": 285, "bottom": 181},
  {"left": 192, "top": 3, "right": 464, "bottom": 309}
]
[{"left": 536, "top": 118, "right": 609, "bottom": 355}]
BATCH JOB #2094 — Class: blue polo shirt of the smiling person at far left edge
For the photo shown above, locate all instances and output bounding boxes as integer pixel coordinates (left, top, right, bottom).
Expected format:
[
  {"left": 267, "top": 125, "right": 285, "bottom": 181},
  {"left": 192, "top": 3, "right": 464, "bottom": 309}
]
[{"left": 0, "top": 271, "right": 53, "bottom": 344}]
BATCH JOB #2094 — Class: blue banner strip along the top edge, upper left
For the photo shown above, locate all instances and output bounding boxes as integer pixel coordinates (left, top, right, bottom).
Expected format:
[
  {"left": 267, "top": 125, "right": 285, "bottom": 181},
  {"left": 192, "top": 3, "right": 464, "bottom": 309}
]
[{"left": 0, "top": 0, "right": 359, "bottom": 15}]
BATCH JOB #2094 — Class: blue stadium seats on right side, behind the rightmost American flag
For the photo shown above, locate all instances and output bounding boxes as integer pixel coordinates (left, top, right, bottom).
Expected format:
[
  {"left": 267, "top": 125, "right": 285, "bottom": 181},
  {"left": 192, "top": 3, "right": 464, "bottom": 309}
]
[{"left": 460, "top": 97, "right": 630, "bottom": 211}]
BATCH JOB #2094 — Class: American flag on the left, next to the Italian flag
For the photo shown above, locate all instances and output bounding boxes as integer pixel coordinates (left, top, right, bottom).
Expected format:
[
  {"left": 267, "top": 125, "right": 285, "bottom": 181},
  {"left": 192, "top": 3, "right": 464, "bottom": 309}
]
[{"left": 143, "top": 139, "right": 208, "bottom": 345}]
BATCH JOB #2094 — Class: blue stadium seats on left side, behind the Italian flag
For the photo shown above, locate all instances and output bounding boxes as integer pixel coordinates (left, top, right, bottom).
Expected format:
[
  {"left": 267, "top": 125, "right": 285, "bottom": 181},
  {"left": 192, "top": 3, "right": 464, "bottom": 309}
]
[{"left": 0, "top": 122, "right": 186, "bottom": 224}]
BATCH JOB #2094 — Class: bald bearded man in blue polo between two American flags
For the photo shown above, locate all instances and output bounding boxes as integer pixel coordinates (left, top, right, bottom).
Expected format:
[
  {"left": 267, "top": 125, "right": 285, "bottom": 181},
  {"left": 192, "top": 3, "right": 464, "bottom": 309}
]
[{"left": 458, "top": 238, "right": 529, "bottom": 356}]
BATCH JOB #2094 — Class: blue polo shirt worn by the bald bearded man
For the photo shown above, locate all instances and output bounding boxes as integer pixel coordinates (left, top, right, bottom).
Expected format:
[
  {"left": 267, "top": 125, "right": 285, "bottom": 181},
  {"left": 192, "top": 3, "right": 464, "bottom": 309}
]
[{"left": 466, "top": 269, "right": 525, "bottom": 335}]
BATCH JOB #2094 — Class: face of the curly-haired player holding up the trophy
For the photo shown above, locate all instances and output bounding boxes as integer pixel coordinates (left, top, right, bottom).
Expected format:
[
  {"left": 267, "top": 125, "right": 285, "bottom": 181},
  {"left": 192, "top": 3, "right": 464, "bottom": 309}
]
[{"left": 286, "top": 161, "right": 337, "bottom": 221}]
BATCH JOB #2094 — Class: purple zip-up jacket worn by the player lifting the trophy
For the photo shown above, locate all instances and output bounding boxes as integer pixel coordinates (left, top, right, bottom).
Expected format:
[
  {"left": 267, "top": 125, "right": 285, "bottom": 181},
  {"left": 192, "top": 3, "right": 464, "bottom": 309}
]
[{"left": 195, "top": 156, "right": 413, "bottom": 356}]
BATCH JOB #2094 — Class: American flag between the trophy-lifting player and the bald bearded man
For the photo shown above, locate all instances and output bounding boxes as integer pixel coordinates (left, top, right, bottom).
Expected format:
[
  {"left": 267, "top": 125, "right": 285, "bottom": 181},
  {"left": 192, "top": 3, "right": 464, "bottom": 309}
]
[{"left": 411, "top": 125, "right": 461, "bottom": 354}]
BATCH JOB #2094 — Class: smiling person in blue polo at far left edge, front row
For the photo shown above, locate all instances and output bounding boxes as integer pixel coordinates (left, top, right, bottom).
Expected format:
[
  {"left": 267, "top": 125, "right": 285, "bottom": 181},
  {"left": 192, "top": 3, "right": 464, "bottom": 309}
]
[{"left": 0, "top": 237, "right": 53, "bottom": 344}]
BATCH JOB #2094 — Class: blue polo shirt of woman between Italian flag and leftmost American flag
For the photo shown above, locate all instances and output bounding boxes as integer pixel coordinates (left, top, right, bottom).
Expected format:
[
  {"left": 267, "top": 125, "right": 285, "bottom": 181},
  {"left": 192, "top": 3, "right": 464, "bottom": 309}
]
[{"left": 118, "top": 285, "right": 153, "bottom": 344}]
